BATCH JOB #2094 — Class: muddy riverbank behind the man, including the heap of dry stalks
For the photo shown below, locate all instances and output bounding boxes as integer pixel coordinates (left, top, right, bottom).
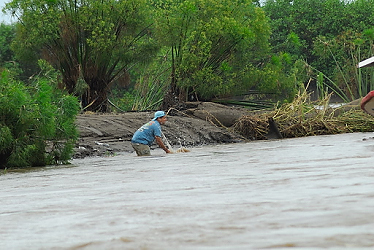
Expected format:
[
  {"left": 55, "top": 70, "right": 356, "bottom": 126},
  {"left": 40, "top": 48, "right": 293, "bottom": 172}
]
[{"left": 73, "top": 99, "right": 366, "bottom": 158}]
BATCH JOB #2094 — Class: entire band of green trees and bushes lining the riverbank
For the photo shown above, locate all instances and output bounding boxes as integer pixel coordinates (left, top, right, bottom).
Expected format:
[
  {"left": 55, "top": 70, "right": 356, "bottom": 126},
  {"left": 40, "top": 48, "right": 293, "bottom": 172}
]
[{"left": 0, "top": 0, "right": 374, "bottom": 166}]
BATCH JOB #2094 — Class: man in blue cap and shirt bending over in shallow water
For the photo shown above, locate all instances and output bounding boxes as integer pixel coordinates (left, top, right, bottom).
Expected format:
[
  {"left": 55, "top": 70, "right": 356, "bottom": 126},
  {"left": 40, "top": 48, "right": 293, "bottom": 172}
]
[{"left": 131, "top": 111, "right": 171, "bottom": 156}]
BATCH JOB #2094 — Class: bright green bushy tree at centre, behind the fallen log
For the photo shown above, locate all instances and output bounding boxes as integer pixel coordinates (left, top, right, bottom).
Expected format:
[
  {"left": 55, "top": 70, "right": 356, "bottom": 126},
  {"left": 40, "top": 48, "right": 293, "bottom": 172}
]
[{"left": 153, "top": 0, "right": 270, "bottom": 107}]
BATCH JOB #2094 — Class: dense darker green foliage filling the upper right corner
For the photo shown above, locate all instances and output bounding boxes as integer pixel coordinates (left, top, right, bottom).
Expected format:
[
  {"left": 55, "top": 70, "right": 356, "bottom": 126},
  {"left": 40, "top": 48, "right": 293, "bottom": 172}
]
[{"left": 263, "top": 0, "right": 374, "bottom": 101}]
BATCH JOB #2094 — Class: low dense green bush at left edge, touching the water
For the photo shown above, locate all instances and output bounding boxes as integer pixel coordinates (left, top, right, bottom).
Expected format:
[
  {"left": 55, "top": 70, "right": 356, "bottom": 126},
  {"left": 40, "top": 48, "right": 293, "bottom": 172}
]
[{"left": 0, "top": 66, "right": 79, "bottom": 168}]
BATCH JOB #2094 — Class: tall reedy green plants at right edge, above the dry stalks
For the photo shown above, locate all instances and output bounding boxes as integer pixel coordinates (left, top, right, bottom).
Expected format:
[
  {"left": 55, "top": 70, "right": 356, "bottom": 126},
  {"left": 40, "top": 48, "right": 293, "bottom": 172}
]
[{"left": 315, "top": 29, "right": 374, "bottom": 102}]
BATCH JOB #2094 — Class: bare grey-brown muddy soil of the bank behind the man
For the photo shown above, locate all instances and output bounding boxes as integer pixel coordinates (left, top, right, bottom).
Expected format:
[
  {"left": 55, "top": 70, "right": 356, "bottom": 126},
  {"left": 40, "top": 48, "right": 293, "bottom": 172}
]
[{"left": 74, "top": 102, "right": 248, "bottom": 158}]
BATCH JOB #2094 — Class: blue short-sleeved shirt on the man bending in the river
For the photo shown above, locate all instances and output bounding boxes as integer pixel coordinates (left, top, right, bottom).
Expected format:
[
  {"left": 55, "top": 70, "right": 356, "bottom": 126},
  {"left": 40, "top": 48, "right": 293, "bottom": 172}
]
[{"left": 131, "top": 121, "right": 161, "bottom": 146}]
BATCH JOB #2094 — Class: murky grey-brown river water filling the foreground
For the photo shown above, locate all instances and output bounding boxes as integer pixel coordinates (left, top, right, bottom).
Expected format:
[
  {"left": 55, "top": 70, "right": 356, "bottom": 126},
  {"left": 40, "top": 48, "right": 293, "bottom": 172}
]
[{"left": 0, "top": 133, "right": 374, "bottom": 249}]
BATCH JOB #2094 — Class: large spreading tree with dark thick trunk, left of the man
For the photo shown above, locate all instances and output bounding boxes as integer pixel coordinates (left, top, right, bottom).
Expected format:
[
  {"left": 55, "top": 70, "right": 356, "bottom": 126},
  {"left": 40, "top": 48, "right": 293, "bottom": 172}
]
[{"left": 6, "top": 0, "right": 157, "bottom": 112}]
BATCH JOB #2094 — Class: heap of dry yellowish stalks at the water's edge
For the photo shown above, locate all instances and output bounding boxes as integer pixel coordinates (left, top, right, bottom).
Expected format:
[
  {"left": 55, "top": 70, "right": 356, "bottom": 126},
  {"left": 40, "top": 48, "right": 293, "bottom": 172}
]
[{"left": 234, "top": 91, "right": 374, "bottom": 140}]
